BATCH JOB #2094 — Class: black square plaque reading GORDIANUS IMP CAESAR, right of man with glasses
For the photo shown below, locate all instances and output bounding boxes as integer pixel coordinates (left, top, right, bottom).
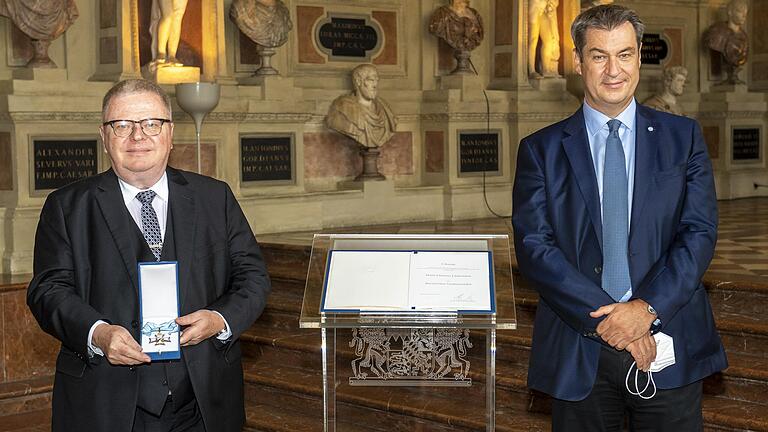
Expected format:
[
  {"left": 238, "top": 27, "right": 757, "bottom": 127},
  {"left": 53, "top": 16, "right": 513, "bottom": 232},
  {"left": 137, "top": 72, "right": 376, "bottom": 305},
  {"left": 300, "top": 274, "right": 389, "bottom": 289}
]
[{"left": 240, "top": 135, "right": 293, "bottom": 182}]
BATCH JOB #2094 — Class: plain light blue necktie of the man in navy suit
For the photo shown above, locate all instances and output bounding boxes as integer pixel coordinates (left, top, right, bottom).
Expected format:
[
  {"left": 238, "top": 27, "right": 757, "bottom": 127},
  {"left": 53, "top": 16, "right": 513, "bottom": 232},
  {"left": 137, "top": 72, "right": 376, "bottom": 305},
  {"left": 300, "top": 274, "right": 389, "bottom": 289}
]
[{"left": 602, "top": 120, "right": 632, "bottom": 301}]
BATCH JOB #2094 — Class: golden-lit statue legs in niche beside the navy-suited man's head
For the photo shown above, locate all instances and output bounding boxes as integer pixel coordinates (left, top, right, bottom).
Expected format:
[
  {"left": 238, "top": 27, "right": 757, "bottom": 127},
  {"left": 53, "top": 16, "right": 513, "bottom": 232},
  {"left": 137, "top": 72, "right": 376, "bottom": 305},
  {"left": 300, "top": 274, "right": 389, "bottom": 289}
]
[{"left": 528, "top": 0, "right": 560, "bottom": 78}]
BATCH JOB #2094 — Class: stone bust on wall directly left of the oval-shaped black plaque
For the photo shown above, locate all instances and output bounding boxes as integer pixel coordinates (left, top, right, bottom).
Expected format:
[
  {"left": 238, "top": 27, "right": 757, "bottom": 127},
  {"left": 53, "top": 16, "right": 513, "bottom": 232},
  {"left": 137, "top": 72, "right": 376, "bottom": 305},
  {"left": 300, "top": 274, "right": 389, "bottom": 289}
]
[{"left": 229, "top": 0, "right": 293, "bottom": 75}]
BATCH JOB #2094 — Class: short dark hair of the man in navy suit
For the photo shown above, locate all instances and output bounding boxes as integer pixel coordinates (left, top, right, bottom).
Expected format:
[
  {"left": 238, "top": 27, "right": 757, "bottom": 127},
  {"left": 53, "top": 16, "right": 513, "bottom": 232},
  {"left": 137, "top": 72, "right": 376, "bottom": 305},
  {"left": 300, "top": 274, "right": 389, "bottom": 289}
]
[{"left": 571, "top": 4, "right": 645, "bottom": 58}]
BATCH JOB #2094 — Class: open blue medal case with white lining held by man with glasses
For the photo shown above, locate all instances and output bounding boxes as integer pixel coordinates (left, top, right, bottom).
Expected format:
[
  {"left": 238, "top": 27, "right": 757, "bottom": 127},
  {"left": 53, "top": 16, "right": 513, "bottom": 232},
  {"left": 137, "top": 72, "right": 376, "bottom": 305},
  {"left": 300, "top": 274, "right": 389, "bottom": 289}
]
[{"left": 139, "top": 261, "right": 181, "bottom": 361}]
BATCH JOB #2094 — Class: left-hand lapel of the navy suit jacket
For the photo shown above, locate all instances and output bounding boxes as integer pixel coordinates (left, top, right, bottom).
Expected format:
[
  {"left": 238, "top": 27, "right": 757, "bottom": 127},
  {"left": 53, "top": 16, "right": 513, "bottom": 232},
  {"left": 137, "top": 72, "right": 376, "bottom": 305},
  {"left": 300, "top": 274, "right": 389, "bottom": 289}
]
[{"left": 562, "top": 109, "right": 603, "bottom": 249}]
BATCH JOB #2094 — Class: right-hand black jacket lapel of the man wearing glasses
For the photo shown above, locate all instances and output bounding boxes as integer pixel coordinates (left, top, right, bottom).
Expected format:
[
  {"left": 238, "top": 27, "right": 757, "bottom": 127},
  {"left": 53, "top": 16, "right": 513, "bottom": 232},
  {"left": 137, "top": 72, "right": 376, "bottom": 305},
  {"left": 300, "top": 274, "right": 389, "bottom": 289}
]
[{"left": 166, "top": 167, "right": 197, "bottom": 313}]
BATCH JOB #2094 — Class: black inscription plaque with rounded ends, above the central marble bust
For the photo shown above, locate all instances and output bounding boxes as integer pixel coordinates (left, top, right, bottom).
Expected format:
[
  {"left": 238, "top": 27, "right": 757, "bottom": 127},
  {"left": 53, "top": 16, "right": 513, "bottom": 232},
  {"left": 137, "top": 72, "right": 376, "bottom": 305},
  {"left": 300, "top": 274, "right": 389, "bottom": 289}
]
[{"left": 316, "top": 15, "right": 381, "bottom": 60}]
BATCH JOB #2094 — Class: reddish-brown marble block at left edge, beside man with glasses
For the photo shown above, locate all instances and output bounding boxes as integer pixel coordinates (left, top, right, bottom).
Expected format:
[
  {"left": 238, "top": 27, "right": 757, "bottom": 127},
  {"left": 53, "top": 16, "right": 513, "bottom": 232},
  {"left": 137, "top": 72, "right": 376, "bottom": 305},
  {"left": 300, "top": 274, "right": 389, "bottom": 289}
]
[{"left": 2, "top": 290, "right": 59, "bottom": 381}]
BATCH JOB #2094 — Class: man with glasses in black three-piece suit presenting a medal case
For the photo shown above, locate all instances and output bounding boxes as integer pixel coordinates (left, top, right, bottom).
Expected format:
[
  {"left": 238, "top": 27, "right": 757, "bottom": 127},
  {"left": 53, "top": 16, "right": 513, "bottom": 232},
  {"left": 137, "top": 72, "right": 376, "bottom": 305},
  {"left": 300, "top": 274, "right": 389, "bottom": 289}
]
[{"left": 27, "top": 80, "right": 270, "bottom": 432}]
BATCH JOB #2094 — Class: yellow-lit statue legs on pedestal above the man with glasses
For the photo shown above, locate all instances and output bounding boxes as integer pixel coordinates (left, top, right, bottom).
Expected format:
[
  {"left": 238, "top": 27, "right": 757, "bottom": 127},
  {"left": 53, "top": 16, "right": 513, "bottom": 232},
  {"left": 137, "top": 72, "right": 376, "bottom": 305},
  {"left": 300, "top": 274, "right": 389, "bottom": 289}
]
[{"left": 149, "top": 0, "right": 187, "bottom": 70}]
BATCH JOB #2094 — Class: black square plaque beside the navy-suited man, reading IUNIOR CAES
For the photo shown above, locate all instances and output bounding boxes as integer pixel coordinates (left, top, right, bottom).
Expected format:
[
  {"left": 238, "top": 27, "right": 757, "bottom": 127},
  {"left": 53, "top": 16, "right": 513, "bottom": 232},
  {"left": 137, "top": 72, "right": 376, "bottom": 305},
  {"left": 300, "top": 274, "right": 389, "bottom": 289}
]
[{"left": 459, "top": 131, "right": 501, "bottom": 174}]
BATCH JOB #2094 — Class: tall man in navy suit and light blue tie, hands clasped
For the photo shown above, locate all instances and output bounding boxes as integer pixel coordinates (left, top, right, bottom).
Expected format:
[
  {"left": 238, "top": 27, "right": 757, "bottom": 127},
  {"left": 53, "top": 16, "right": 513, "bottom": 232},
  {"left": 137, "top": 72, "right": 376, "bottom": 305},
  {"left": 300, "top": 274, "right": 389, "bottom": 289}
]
[{"left": 512, "top": 4, "right": 727, "bottom": 432}]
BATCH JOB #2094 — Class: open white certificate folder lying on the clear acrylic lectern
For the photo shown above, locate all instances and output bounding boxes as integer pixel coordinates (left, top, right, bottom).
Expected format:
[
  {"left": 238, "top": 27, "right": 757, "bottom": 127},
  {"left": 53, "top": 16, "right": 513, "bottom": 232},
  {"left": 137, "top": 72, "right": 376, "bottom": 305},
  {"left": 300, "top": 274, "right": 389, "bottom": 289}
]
[{"left": 322, "top": 250, "right": 495, "bottom": 312}]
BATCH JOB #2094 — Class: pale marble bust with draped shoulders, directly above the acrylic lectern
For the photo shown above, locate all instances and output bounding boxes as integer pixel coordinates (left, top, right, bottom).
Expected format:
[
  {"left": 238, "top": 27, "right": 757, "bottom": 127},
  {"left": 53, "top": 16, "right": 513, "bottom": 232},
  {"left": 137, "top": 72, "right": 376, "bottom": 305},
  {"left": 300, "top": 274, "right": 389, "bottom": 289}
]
[{"left": 325, "top": 64, "right": 397, "bottom": 180}]
